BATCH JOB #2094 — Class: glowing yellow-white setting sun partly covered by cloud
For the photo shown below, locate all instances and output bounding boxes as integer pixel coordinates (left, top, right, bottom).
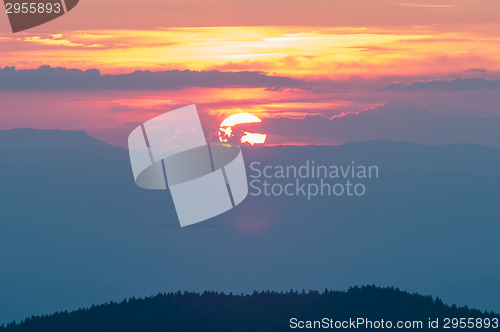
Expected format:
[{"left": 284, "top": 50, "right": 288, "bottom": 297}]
[{"left": 219, "top": 113, "right": 267, "bottom": 145}]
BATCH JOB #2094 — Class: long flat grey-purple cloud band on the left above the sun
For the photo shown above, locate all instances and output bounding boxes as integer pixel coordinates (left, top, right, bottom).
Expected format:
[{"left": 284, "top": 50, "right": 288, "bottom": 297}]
[{"left": 0, "top": 66, "right": 307, "bottom": 91}]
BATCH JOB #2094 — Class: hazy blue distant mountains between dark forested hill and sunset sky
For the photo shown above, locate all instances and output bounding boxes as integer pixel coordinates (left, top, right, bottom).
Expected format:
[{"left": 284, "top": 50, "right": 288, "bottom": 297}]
[{"left": 0, "top": 130, "right": 500, "bottom": 323}]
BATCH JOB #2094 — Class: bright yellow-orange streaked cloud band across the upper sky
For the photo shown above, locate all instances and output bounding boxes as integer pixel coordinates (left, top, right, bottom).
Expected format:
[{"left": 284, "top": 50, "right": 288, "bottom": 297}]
[{"left": 0, "top": 25, "right": 500, "bottom": 79}]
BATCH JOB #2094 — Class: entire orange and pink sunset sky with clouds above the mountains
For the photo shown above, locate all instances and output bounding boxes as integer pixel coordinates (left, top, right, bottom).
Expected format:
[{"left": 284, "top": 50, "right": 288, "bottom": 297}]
[{"left": 0, "top": 0, "right": 500, "bottom": 146}]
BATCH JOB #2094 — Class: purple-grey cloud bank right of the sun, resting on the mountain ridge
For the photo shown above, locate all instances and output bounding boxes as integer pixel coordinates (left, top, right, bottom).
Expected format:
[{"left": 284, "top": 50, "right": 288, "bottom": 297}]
[{"left": 239, "top": 101, "right": 500, "bottom": 148}]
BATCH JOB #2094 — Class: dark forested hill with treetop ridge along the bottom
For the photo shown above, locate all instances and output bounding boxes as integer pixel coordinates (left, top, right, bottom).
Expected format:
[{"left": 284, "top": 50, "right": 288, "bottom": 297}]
[{"left": 0, "top": 286, "right": 500, "bottom": 332}]
